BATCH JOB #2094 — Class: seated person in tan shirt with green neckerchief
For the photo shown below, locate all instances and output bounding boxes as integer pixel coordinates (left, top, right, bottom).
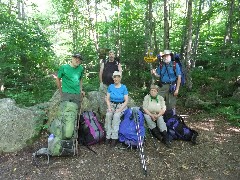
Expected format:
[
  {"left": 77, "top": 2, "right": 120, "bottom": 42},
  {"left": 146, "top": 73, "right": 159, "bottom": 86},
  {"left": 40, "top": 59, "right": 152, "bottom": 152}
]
[{"left": 143, "top": 85, "right": 170, "bottom": 147}]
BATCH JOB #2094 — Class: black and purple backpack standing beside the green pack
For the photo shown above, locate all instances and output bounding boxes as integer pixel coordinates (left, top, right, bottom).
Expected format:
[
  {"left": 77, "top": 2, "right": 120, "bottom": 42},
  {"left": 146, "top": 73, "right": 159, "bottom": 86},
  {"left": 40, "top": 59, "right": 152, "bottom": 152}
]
[{"left": 78, "top": 111, "right": 105, "bottom": 146}]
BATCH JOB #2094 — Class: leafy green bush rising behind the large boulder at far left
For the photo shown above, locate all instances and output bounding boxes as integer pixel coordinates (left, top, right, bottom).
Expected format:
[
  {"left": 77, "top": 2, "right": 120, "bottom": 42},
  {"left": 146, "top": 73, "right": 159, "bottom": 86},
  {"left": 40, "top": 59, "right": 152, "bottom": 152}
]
[{"left": 0, "top": 5, "right": 55, "bottom": 106}]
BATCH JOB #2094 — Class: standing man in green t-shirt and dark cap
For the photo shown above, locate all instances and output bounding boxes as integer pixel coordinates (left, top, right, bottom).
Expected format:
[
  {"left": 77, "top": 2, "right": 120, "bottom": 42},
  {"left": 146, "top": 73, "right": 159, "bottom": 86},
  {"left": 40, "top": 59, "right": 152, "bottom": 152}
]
[{"left": 56, "top": 54, "right": 85, "bottom": 108}]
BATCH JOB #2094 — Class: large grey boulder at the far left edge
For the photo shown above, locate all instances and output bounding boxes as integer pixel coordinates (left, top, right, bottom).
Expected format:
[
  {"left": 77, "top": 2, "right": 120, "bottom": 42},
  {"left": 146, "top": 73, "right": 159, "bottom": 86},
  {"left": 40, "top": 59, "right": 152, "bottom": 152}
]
[{"left": 0, "top": 98, "right": 44, "bottom": 153}]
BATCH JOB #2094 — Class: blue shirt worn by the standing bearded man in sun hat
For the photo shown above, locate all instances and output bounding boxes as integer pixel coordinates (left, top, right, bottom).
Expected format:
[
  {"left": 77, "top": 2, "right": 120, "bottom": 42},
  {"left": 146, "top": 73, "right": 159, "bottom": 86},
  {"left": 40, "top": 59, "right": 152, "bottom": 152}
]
[{"left": 157, "top": 62, "right": 181, "bottom": 83}]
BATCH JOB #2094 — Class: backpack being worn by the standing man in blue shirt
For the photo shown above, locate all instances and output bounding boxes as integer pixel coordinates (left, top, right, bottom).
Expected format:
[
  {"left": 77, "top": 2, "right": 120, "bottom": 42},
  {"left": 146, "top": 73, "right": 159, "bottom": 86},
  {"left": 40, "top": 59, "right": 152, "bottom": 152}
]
[{"left": 159, "top": 54, "right": 186, "bottom": 86}]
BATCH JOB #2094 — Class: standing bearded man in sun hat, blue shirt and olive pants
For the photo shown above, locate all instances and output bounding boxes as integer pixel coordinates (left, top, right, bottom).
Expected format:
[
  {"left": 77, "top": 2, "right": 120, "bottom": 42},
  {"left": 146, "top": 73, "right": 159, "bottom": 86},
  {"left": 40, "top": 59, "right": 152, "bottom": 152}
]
[{"left": 152, "top": 50, "right": 181, "bottom": 113}]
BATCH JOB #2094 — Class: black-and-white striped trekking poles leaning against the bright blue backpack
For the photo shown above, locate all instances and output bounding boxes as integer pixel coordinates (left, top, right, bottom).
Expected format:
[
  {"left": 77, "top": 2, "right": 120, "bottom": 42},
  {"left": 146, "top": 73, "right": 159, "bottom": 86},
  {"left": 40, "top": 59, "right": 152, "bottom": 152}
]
[{"left": 132, "top": 108, "right": 147, "bottom": 176}]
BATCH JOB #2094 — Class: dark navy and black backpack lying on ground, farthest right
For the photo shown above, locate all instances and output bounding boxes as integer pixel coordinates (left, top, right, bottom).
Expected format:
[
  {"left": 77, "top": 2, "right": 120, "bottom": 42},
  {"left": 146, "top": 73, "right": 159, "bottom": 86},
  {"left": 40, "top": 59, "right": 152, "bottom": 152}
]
[{"left": 163, "top": 110, "right": 198, "bottom": 144}]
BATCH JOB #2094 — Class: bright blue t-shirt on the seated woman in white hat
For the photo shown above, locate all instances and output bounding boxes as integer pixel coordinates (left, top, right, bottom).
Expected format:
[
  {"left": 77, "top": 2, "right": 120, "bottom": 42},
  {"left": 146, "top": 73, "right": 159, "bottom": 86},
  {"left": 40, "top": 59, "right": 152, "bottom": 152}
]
[{"left": 107, "top": 84, "right": 128, "bottom": 103}]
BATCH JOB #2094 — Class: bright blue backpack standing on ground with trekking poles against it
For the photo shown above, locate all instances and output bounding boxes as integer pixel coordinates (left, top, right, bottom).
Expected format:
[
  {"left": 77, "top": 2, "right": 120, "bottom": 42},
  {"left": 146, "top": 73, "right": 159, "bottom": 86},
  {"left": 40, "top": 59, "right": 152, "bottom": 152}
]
[{"left": 118, "top": 107, "right": 145, "bottom": 147}]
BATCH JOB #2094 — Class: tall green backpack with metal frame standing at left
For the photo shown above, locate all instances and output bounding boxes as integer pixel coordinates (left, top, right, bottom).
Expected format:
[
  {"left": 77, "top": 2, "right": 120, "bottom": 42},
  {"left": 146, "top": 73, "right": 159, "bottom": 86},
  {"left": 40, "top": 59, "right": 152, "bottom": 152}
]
[{"left": 33, "top": 101, "right": 78, "bottom": 163}]
